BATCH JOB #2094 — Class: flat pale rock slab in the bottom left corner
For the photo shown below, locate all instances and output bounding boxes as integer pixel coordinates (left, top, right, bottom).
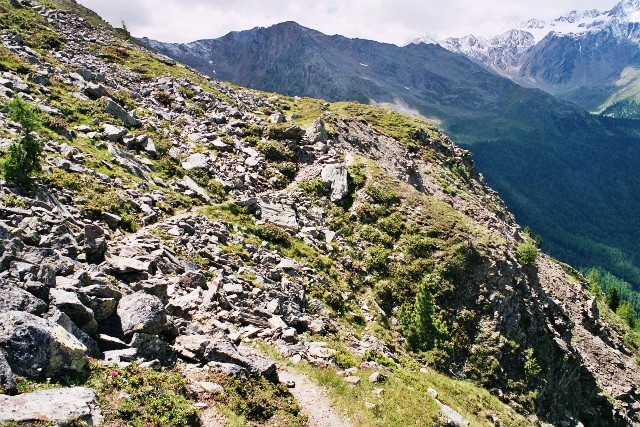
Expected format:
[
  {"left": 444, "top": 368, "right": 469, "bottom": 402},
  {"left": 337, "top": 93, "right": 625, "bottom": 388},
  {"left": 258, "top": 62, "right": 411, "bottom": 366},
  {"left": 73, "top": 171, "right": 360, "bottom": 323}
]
[{"left": 0, "top": 387, "right": 103, "bottom": 426}]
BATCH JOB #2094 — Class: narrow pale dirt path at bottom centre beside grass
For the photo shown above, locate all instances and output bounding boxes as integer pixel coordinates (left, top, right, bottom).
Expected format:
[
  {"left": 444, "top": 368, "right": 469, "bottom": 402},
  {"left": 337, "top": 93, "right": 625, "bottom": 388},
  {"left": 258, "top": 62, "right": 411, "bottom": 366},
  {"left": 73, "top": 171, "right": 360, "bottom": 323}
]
[{"left": 278, "top": 366, "right": 351, "bottom": 427}]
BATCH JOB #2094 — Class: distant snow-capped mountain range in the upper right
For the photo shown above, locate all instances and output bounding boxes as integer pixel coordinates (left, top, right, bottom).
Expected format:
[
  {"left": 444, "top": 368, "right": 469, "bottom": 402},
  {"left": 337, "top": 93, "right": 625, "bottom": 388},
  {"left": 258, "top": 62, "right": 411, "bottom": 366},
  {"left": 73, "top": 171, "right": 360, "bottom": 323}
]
[{"left": 436, "top": 0, "right": 640, "bottom": 112}]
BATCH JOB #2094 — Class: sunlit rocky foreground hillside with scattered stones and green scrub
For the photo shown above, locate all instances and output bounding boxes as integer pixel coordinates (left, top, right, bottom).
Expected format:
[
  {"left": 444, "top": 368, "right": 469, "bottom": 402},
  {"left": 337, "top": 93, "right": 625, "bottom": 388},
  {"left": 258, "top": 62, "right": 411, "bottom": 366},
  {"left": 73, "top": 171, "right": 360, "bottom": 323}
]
[{"left": 0, "top": 0, "right": 640, "bottom": 426}]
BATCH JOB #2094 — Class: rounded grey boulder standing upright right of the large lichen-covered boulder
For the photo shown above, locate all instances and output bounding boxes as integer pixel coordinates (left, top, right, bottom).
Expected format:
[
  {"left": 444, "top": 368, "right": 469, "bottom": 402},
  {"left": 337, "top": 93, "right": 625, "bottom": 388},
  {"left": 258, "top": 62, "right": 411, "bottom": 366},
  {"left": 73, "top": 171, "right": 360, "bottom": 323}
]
[{"left": 117, "top": 292, "right": 167, "bottom": 335}]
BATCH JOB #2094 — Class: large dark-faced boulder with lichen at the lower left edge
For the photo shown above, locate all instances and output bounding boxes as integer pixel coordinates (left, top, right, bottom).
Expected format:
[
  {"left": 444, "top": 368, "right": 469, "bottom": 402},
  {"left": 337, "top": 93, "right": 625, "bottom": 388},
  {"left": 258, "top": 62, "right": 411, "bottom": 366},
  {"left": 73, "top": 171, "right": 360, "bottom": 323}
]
[{"left": 0, "top": 311, "right": 87, "bottom": 380}]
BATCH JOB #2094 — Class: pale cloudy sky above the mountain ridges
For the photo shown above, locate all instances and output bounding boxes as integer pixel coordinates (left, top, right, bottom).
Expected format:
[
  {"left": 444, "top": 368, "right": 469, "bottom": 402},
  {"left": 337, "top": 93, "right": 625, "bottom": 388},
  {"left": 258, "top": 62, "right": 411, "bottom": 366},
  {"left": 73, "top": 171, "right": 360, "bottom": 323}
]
[{"left": 78, "top": 0, "right": 617, "bottom": 44}]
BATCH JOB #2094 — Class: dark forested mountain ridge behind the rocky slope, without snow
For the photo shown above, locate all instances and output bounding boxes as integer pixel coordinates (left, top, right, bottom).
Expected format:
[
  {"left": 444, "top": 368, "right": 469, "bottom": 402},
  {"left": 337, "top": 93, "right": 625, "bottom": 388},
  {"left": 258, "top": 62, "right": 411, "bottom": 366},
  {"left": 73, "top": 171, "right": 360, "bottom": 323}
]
[{"left": 144, "top": 22, "right": 640, "bottom": 294}]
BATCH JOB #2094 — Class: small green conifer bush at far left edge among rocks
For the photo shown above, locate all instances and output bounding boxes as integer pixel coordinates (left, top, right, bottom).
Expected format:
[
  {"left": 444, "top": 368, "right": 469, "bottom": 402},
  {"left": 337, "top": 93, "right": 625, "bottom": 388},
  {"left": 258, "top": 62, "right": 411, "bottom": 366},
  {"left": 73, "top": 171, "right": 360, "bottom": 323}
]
[{"left": 2, "top": 97, "right": 42, "bottom": 185}]
